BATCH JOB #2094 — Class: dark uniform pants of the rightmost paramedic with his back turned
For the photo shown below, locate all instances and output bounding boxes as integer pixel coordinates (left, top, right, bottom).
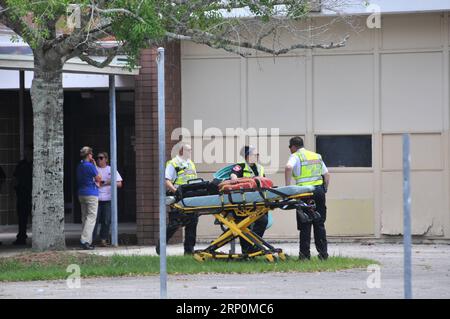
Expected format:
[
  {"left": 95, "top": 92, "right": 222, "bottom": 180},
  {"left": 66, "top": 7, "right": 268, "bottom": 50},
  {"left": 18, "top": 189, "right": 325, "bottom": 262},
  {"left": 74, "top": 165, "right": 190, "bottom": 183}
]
[{"left": 297, "top": 186, "right": 328, "bottom": 258}]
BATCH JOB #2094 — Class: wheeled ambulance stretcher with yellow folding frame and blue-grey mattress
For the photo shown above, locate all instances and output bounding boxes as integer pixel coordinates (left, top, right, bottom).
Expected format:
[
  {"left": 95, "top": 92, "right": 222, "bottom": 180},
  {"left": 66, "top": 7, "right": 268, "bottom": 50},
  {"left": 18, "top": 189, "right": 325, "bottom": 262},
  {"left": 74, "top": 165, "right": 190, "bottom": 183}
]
[{"left": 168, "top": 186, "right": 315, "bottom": 262}]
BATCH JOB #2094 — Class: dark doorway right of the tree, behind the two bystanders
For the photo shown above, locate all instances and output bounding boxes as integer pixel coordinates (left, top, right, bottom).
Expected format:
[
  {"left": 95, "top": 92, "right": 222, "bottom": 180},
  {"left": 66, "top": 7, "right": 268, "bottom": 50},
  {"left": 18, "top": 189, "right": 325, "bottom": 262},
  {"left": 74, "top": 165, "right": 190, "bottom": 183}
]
[{"left": 64, "top": 90, "right": 136, "bottom": 223}]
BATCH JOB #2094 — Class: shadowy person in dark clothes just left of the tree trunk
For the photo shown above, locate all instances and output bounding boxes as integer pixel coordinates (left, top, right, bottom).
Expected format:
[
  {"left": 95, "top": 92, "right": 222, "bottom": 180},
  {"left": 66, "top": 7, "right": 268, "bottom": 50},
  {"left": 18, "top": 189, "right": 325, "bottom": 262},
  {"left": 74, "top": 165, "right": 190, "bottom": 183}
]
[{"left": 13, "top": 145, "right": 33, "bottom": 246}]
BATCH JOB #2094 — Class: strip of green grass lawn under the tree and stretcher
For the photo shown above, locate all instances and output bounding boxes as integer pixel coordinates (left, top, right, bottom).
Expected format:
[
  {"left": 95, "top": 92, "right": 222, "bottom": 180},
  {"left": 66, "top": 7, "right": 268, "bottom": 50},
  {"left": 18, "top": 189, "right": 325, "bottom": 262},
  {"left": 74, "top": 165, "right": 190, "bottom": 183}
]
[{"left": 0, "top": 252, "right": 377, "bottom": 281}]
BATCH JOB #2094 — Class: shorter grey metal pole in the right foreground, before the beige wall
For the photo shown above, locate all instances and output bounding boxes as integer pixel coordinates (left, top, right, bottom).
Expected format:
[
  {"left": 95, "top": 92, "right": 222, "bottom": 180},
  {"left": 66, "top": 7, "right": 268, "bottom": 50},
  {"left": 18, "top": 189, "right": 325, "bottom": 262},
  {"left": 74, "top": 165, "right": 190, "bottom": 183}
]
[{"left": 403, "top": 134, "right": 412, "bottom": 299}]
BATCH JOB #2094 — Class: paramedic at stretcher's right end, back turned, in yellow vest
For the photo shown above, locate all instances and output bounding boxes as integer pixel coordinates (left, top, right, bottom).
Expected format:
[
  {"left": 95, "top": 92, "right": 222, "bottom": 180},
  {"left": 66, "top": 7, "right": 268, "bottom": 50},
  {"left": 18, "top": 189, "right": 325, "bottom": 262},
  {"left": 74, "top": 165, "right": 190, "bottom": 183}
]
[{"left": 285, "top": 137, "right": 330, "bottom": 260}]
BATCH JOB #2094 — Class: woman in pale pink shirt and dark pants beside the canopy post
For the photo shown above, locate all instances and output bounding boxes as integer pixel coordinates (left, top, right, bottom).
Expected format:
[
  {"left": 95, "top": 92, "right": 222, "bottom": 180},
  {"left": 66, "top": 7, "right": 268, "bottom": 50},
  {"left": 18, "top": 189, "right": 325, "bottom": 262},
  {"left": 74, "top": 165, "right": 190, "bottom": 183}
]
[{"left": 93, "top": 152, "right": 123, "bottom": 247}]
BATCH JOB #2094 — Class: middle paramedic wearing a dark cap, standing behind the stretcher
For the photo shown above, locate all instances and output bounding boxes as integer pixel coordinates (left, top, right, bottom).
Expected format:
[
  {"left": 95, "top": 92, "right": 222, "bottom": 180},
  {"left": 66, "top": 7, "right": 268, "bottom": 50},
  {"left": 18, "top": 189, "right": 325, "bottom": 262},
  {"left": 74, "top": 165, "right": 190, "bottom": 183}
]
[{"left": 230, "top": 145, "right": 269, "bottom": 254}]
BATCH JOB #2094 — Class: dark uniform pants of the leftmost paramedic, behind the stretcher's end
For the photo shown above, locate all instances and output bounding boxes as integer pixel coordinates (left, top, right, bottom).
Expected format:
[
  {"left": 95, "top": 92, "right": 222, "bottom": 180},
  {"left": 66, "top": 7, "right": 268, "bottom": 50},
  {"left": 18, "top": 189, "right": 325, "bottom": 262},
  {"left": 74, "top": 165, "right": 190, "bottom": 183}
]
[{"left": 166, "top": 211, "right": 198, "bottom": 253}]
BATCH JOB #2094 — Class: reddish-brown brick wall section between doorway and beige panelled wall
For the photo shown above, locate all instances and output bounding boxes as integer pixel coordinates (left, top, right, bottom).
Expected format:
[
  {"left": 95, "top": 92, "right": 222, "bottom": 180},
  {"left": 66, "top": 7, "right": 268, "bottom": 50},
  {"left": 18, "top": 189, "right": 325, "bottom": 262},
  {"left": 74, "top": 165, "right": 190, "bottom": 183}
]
[{"left": 135, "top": 42, "right": 181, "bottom": 245}]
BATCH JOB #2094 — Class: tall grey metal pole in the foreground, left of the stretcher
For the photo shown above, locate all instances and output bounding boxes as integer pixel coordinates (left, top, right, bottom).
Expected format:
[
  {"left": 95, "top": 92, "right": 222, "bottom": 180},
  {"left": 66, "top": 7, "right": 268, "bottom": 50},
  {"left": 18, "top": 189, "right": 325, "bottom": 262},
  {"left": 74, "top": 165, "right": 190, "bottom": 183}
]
[{"left": 157, "top": 48, "right": 167, "bottom": 299}]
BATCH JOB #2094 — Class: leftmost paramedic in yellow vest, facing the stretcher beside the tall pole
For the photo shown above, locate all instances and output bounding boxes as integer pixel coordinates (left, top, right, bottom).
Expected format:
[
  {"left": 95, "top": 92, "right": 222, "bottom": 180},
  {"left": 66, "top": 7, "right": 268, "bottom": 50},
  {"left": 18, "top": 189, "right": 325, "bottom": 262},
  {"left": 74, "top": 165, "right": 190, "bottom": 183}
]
[{"left": 156, "top": 144, "right": 198, "bottom": 255}]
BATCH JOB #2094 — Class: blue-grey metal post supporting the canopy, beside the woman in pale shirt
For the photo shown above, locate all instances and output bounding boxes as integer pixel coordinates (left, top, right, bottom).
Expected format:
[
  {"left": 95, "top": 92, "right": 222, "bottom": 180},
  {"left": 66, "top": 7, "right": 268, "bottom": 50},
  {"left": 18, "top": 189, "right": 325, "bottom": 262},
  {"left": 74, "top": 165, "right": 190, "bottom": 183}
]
[{"left": 109, "top": 75, "right": 118, "bottom": 246}]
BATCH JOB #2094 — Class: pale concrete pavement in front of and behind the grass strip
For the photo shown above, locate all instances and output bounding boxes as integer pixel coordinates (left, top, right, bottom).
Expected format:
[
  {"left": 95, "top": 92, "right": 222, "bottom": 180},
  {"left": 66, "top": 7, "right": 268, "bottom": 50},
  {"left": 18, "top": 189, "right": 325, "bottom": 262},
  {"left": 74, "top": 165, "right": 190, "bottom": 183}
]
[{"left": 0, "top": 244, "right": 450, "bottom": 299}]
